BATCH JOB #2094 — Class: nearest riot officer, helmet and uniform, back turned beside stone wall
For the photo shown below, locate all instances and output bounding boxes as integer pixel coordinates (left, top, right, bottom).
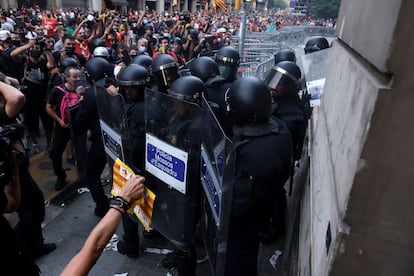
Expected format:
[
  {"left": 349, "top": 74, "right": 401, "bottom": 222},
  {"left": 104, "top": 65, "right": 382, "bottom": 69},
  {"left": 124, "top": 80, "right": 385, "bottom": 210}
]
[{"left": 225, "top": 77, "right": 292, "bottom": 276}]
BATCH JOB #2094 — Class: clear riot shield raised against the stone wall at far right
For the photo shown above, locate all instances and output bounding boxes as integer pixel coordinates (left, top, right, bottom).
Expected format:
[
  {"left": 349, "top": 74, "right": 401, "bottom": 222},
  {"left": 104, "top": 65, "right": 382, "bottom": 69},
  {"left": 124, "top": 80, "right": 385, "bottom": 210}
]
[{"left": 298, "top": 48, "right": 330, "bottom": 107}]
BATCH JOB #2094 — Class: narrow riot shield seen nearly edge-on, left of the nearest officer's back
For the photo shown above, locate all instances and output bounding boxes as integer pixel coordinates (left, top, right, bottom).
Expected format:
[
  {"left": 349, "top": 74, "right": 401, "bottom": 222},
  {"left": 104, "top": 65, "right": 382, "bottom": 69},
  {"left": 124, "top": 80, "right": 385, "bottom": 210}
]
[{"left": 200, "top": 97, "right": 234, "bottom": 275}]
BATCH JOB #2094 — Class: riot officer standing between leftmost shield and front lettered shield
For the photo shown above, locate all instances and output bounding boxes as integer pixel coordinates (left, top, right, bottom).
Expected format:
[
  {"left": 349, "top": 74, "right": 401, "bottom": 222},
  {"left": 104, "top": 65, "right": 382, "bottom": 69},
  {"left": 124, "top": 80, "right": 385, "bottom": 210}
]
[{"left": 117, "top": 64, "right": 150, "bottom": 258}]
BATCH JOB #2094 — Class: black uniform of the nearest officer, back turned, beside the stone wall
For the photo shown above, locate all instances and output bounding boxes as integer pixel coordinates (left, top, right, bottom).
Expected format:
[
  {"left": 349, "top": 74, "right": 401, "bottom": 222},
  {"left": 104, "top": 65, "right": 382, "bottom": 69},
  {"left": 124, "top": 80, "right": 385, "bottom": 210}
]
[{"left": 225, "top": 119, "right": 291, "bottom": 276}]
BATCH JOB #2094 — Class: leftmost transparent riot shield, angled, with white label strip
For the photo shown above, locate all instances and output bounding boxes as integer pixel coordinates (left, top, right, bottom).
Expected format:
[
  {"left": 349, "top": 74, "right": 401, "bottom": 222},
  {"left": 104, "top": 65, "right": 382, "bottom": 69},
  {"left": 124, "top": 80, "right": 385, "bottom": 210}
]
[{"left": 93, "top": 86, "right": 131, "bottom": 164}]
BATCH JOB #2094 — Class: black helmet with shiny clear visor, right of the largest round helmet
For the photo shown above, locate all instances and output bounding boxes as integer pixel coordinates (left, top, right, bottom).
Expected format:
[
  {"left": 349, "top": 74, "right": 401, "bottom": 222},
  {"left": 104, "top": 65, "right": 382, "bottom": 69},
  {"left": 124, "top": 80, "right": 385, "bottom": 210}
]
[{"left": 264, "top": 61, "right": 302, "bottom": 90}]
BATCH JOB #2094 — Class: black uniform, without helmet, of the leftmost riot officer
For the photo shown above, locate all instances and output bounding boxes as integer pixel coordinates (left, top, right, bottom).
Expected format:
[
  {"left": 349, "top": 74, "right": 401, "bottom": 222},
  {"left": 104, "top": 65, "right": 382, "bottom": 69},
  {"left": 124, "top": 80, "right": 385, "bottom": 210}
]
[{"left": 72, "top": 87, "right": 109, "bottom": 216}]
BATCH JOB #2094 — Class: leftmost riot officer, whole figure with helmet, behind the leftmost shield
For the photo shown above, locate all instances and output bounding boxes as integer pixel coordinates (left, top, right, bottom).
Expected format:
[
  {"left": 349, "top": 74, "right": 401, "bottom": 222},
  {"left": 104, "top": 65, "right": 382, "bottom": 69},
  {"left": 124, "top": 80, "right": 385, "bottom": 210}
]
[{"left": 72, "top": 57, "right": 112, "bottom": 217}]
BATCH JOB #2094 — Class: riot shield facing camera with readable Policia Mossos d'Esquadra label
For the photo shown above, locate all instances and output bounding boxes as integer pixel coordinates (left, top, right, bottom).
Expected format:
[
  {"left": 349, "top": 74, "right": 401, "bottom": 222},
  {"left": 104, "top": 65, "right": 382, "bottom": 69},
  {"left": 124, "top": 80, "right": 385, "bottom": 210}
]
[{"left": 145, "top": 89, "right": 201, "bottom": 251}]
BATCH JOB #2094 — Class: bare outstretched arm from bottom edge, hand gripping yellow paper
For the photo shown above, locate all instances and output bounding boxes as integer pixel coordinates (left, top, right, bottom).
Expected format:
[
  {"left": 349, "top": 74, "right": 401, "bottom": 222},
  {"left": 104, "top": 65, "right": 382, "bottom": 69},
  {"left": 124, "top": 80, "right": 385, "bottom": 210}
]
[{"left": 61, "top": 175, "right": 145, "bottom": 276}]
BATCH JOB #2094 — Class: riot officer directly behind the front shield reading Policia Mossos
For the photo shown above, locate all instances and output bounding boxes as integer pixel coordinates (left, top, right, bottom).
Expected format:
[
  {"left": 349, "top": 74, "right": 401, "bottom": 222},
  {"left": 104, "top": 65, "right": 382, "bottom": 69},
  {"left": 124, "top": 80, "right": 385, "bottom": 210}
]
[{"left": 157, "top": 76, "right": 207, "bottom": 276}]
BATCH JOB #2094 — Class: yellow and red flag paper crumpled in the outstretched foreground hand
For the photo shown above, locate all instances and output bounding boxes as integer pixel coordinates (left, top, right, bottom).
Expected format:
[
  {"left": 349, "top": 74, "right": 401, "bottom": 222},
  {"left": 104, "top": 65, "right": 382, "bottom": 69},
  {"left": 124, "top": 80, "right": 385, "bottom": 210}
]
[{"left": 111, "top": 158, "right": 155, "bottom": 231}]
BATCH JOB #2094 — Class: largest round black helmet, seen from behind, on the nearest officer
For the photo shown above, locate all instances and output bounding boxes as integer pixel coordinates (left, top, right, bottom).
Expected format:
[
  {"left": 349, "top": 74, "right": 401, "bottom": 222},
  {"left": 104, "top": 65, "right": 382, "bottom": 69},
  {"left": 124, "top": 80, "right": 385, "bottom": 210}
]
[{"left": 226, "top": 77, "right": 272, "bottom": 125}]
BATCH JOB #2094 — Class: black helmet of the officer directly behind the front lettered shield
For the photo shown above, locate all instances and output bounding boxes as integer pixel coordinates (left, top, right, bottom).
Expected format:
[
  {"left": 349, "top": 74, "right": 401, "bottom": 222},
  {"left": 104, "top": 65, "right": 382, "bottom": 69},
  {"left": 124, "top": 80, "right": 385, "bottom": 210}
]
[{"left": 168, "top": 76, "right": 207, "bottom": 105}]
